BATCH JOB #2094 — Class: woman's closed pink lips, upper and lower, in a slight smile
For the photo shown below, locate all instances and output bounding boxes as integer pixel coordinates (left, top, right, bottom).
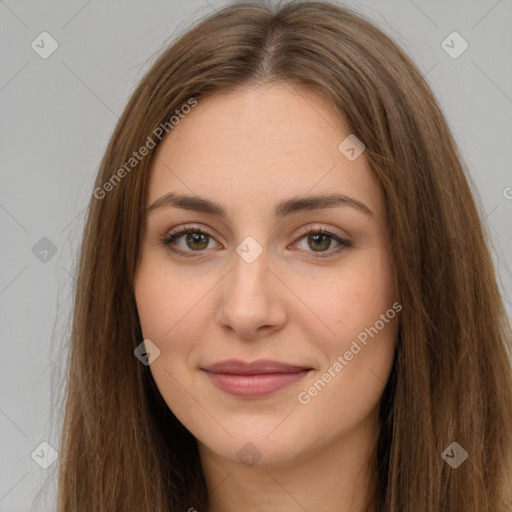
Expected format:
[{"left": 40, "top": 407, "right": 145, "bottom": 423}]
[{"left": 201, "top": 359, "right": 312, "bottom": 398}]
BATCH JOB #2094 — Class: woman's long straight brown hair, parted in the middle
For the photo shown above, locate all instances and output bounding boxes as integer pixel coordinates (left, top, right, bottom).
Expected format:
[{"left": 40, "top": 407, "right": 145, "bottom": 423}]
[{"left": 58, "top": 1, "right": 512, "bottom": 512}]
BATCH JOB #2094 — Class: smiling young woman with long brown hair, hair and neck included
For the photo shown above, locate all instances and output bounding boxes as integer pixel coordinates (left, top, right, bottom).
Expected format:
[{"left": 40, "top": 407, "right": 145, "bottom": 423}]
[{"left": 59, "top": 2, "right": 512, "bottom": 512}]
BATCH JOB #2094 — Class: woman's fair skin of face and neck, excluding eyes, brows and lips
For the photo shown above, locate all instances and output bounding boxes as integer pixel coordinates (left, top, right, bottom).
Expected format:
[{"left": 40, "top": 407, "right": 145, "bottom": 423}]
[{"left": 134, "top": 84, "right": 396, "bottom": 512}]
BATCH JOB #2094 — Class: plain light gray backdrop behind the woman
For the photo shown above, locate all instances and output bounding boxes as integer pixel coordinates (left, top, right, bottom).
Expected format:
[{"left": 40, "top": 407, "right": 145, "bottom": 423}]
[{"left": 0, "top": 0, "right": 512, "bottom": 512}]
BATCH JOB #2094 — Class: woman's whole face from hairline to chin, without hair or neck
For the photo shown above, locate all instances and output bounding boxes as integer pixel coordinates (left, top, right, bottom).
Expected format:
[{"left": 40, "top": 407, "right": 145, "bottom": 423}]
[{"left": 135, "top": 84, "right": 401, "bottom": 465}]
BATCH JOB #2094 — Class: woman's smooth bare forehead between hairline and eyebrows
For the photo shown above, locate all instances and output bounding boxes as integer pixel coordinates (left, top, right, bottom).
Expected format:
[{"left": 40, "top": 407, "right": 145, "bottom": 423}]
[{"left": 144, "top": 84, "right": 379, "bottom": 218}]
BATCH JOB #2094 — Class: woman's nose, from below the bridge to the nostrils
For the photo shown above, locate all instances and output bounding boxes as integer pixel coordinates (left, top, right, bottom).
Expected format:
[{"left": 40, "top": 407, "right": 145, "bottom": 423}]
[{"left": 216, "top": 246, "right": 286, "bottom": 341}]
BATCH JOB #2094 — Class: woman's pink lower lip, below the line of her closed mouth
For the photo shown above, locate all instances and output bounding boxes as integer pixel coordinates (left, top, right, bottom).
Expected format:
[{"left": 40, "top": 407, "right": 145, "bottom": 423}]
[{"left": 202, "top": 370, "right": 310, "bottom": 398}]
